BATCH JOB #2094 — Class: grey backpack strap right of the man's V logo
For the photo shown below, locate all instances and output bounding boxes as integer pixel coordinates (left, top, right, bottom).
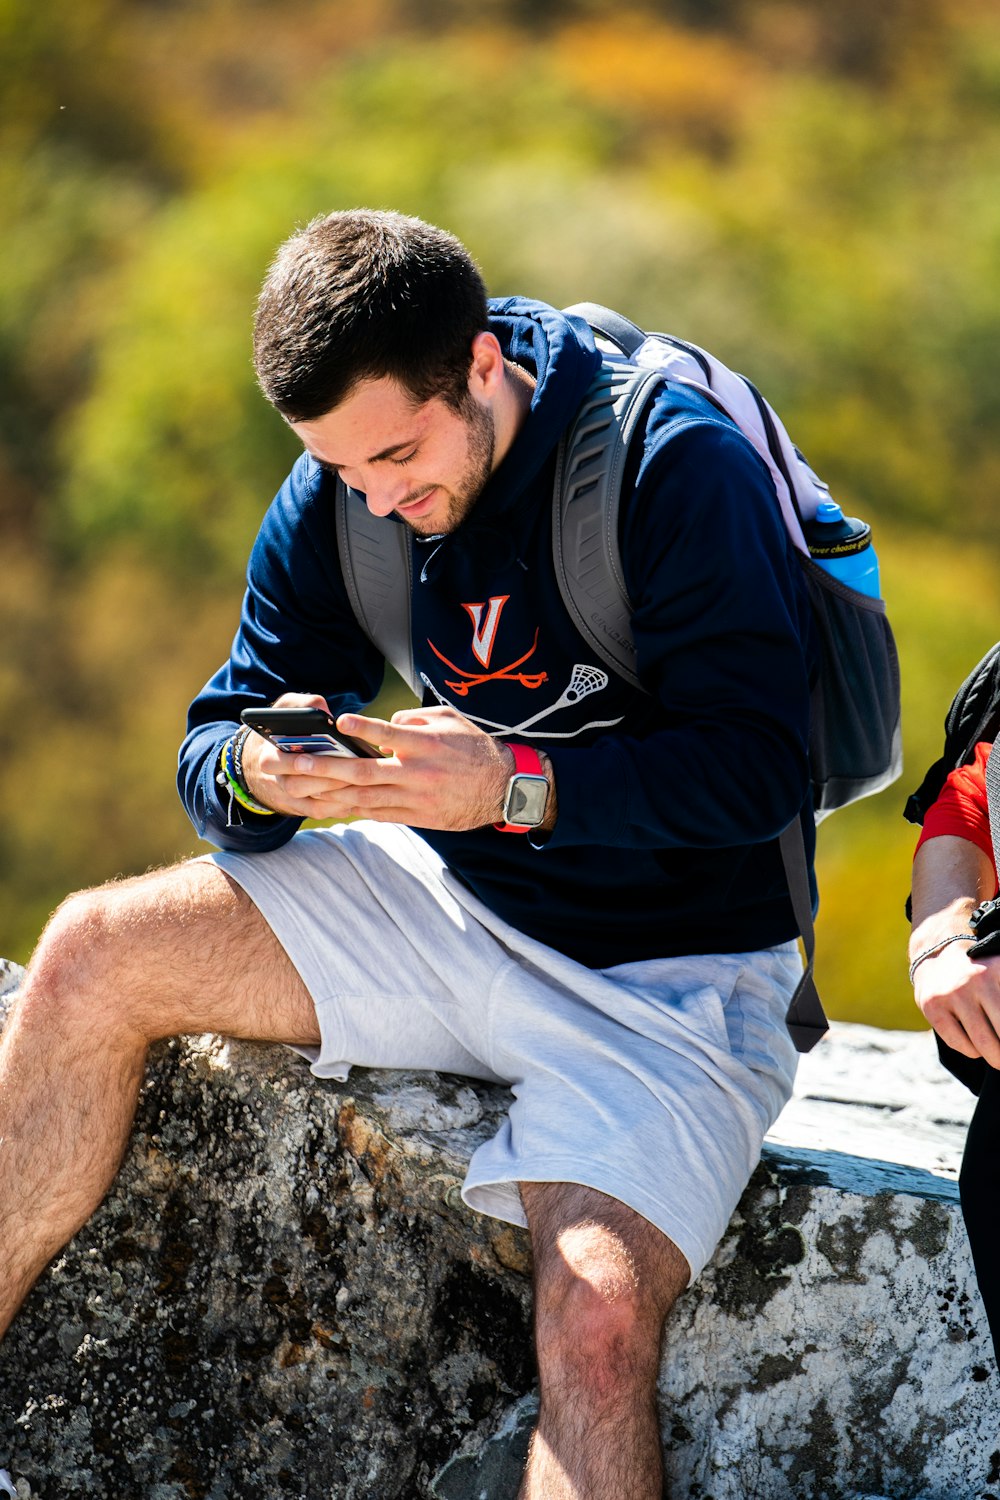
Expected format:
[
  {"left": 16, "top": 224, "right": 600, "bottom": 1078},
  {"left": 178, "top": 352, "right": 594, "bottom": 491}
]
[{"left": 552, "top": 354, "right": 663, "bottom": 687}]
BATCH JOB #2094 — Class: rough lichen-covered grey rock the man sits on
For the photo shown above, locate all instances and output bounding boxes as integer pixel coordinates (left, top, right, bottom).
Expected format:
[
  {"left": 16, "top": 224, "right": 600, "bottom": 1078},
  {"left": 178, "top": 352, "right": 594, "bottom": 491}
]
[{"left": 0, "top": 966, "right": 1000, "bottom": 1500}]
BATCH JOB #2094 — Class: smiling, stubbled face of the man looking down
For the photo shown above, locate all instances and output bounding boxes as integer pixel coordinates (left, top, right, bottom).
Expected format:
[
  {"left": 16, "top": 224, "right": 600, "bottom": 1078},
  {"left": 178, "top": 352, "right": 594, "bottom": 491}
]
[{"left": 291, "top": 378, "right": 496, "bottom": 537}]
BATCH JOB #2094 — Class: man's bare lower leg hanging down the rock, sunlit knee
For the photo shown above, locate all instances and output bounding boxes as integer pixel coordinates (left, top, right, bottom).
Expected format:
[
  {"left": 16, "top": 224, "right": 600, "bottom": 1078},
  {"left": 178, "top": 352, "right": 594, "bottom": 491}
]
[{"left": 519, "top": 1182, "right": 690, "bottom": 1500}]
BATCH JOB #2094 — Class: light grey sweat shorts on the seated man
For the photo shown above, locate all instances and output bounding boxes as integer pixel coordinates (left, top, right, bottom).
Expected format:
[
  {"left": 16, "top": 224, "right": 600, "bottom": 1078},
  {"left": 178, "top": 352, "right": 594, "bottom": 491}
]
[{"left": 207, "top": 822, "right": 801, "bottom": 1280}]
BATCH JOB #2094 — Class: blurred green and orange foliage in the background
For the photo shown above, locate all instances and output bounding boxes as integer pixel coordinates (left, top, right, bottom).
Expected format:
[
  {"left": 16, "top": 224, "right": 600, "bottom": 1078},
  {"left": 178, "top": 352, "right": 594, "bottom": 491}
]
[{"left": 0, "top": 0, "right": 1000, "bottom": 1026}]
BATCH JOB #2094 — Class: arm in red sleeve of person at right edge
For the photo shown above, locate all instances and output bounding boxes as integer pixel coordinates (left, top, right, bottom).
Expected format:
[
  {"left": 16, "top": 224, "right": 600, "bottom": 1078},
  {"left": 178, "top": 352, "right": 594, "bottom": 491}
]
[{"left": 909, "top": 746, "right": 1000, "bottom": 1068}]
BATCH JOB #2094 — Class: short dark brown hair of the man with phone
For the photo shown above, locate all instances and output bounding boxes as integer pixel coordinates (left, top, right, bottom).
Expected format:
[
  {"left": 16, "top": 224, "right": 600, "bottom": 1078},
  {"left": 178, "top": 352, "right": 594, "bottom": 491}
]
[{"left": 253, "top": 209, "right": 487, "bottom": 422}]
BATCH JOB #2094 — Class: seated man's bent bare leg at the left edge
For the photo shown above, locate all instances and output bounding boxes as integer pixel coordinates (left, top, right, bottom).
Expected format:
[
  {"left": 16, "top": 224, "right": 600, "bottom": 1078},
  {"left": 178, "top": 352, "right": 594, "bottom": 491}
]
[{"left": 0, "top": 863, "right": 319, "bottom": 1335}]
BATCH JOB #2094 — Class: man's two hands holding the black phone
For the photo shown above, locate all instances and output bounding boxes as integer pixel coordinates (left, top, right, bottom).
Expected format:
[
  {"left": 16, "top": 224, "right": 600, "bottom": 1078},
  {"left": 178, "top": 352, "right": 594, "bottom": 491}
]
[{"left": 243, "top": 693, "right": 555, "bottom": 831}]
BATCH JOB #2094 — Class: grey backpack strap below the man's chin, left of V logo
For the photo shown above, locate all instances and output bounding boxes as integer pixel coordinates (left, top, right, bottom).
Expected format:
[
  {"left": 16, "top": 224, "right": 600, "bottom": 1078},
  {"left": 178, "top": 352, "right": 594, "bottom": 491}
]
[{"left": 334, "top": 479, "right": 423, "bottom": 698}]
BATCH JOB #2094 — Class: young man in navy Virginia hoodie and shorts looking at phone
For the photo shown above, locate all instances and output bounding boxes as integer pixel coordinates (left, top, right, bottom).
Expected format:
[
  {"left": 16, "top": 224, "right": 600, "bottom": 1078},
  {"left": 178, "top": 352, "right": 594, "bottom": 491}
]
[{"left": 0, "top": 212, "right": 813, "bottom": 1500}]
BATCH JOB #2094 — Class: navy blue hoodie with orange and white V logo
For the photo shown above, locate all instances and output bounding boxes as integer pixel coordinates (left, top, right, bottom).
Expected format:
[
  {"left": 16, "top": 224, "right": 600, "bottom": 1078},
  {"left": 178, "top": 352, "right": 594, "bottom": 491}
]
[{"left": 178, "top": 299, "right": 814, "bottom": 968}]
